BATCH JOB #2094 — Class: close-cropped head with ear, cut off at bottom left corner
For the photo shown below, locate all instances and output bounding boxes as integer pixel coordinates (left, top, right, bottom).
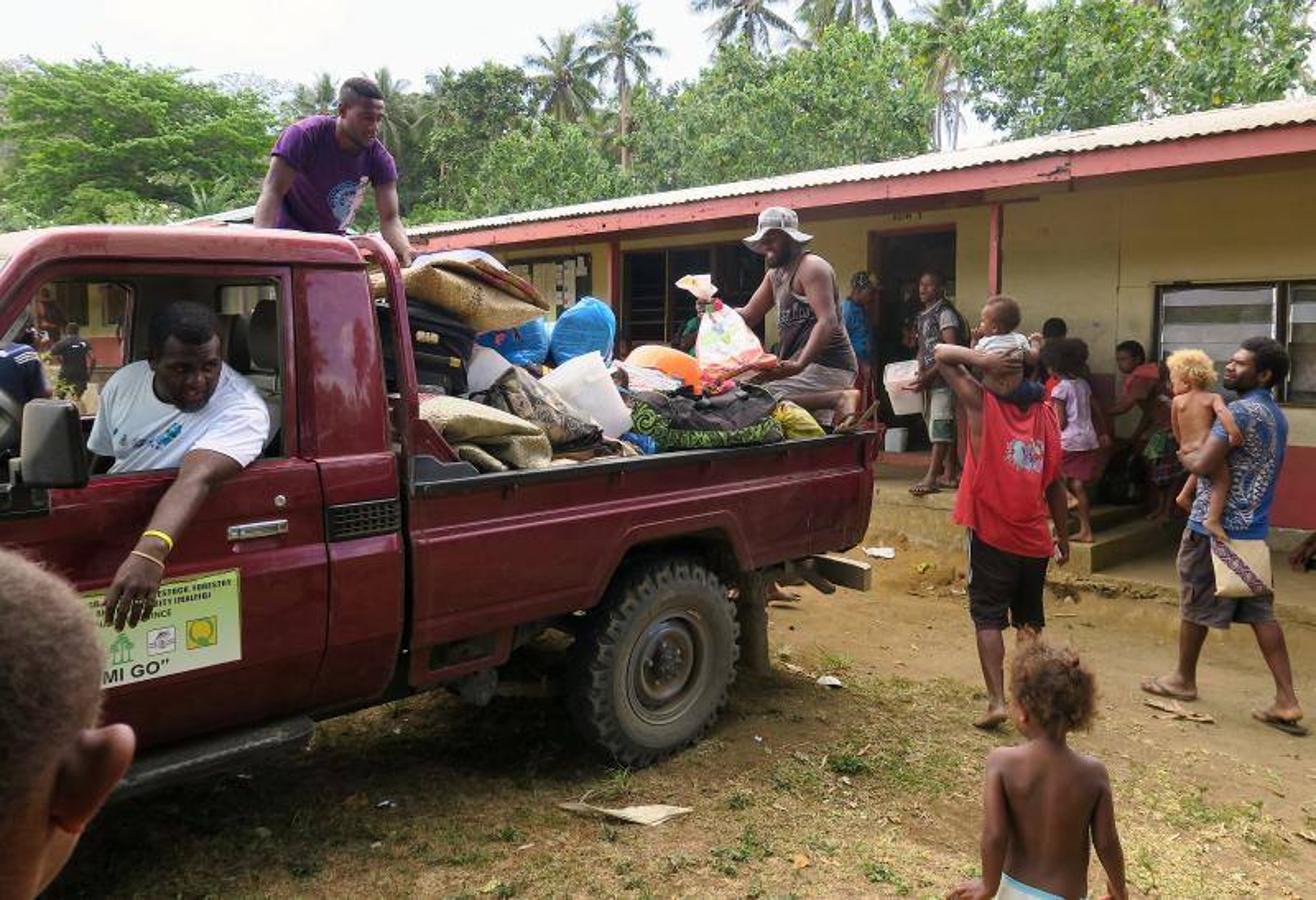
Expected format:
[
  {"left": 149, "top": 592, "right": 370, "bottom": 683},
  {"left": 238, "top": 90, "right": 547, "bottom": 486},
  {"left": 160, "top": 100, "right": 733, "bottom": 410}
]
[{"left": 0, "top": 550, "right": 134, "bottom": 900}]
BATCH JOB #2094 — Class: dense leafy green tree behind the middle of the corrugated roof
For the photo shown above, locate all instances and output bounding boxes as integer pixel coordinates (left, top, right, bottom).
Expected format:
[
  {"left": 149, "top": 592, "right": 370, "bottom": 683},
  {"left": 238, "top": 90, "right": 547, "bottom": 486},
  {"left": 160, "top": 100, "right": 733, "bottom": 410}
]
[{"left": 629, "top": 22, "right": 934, "bottom": 189}]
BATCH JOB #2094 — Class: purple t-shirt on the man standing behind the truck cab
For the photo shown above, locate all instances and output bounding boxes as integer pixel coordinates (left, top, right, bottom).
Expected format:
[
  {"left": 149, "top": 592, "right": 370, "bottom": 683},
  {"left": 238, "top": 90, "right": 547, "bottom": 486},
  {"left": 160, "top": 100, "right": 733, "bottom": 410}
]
[{"left": 270, "top": 116, "right": 397, "bottom": 234}]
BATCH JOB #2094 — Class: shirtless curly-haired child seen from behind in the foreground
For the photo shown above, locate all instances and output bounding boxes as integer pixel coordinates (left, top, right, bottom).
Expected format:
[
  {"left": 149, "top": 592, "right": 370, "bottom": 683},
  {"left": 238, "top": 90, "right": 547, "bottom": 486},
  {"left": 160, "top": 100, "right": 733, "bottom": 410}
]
[{"left": 950, "top": 639, "right": 1128, "bottom": 900}]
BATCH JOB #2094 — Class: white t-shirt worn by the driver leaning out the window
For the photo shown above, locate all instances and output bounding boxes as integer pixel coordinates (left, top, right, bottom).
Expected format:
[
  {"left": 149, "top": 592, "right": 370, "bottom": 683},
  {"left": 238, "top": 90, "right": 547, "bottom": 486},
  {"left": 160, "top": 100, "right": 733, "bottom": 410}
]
[{"left": 87, "top": 359, "right": 270, "bottom": 474}]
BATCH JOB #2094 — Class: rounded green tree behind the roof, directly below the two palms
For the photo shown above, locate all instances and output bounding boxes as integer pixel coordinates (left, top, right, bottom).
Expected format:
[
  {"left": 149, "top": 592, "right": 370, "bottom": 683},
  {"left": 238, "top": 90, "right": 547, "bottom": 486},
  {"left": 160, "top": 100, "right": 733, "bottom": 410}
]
[{"left": 463, "top": 118, "right": 630, "bottom": 216}]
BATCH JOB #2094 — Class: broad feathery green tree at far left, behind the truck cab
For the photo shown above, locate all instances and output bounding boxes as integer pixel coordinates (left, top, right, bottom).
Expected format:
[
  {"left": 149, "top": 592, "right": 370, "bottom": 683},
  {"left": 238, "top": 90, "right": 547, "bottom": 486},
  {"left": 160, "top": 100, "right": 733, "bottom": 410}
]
[{"left": 0, "top": 58, "right": 274, "bottom": 222}]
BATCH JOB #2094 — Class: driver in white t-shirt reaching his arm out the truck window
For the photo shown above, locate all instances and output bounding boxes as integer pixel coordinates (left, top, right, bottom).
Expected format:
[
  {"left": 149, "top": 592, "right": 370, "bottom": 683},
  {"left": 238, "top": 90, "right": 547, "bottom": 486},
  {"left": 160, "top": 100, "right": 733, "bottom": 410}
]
[{"left": 87, "top": 301, "right": 270, "bottom": 630}]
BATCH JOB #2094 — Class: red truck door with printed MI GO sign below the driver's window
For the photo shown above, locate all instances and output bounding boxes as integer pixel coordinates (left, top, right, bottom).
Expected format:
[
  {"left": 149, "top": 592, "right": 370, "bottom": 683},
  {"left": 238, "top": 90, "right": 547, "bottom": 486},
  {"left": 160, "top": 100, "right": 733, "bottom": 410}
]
[{"left": 0, "top": 262, "right": 328, "bottom": 746}]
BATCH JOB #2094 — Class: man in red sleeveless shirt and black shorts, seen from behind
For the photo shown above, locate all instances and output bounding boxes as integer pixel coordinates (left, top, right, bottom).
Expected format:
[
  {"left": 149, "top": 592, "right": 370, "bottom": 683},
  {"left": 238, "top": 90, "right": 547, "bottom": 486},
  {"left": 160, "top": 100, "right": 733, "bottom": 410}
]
[{"left": 936, "top": 297, "right": 1069, "bottom": 729}]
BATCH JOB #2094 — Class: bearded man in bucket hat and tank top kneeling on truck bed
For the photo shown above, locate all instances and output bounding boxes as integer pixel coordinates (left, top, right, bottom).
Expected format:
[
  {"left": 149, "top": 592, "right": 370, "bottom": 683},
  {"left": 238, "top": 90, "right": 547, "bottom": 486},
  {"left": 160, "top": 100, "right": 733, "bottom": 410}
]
[{"left": 738, "top": 207, "right": 859, "bottom": 424}]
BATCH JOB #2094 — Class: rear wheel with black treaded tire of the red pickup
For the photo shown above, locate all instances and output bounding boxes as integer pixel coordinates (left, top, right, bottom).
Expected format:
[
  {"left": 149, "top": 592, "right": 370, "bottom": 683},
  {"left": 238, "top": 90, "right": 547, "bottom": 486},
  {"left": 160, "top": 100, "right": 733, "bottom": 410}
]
[{"left": 570, "top": 558, "right": 740, "bottom": 767}]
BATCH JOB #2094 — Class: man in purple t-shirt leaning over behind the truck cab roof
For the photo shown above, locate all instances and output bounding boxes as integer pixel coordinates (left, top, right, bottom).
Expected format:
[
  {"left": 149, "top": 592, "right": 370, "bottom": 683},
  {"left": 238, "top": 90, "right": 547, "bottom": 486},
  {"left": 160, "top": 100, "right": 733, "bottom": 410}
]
[{"left": 248, "top": 78, "right": 412, "bottom": 266}]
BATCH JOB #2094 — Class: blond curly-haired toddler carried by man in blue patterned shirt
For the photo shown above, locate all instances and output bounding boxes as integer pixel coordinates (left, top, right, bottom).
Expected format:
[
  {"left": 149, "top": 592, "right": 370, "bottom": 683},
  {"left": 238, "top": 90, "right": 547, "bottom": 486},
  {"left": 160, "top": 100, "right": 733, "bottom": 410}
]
[{"left": 1165, "top": 350, "right": 1242, "bottom": 543}]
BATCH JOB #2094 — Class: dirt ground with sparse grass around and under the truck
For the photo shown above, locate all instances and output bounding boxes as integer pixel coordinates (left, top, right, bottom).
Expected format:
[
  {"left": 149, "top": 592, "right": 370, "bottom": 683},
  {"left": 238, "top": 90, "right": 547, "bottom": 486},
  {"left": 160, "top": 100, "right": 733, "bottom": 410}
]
[{"left": 53, "top": 534, "right": 1316, "bottom": 897}]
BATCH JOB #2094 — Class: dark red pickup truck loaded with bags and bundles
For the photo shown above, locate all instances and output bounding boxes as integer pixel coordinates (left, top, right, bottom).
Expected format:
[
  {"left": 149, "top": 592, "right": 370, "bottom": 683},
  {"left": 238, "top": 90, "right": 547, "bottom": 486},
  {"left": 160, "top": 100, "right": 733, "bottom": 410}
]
[{"left": 0, "top": 226, "right": 874, "bottom": 787}]
